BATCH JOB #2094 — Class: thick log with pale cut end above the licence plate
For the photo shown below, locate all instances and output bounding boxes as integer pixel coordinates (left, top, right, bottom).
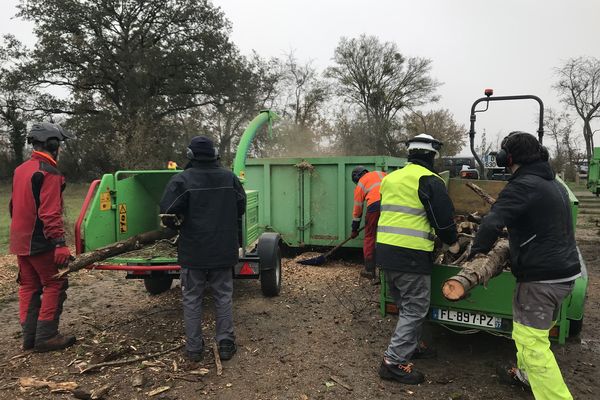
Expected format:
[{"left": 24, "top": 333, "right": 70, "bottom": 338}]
[{"left": 442, "top": 239, "right": 510, "bottom": 301}]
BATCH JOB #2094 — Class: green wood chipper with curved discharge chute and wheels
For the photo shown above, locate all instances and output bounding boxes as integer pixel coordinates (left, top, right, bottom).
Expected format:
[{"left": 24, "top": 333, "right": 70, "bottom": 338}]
[{"left": 75, "top": 111, "right": 281, "bottom": 296}]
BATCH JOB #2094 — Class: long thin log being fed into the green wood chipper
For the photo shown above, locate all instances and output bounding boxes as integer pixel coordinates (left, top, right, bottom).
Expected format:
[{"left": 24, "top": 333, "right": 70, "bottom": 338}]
[{"left": 56, "top": 228, "right": 177, "bottom": 278}]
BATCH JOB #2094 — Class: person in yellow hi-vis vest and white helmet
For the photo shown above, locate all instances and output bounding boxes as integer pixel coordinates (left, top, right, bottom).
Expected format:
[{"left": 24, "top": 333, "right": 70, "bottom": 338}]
[{"left": 375, "top": 134, "right": 459, "bottom": 385}]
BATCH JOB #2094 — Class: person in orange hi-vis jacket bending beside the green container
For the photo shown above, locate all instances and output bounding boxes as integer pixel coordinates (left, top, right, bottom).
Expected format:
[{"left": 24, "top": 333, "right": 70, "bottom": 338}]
[{"left": 351, "top": 165, "right": 385, "bottom": 279}]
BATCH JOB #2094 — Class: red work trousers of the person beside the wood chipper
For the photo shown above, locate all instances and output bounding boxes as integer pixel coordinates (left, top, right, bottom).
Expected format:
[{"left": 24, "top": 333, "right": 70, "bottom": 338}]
[{"left": 17, "top": 250, "right": 69, "bottom": 341}]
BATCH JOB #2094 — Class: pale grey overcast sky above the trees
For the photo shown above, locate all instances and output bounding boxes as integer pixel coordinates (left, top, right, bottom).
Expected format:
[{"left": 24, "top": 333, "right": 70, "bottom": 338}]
[{"left": 0, "top": 0, "right": 600, "bottom": 155}]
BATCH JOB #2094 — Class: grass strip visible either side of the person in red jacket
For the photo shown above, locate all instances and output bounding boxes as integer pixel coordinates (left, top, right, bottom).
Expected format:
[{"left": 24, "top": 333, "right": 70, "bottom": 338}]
[{"left": 0, "top": 182, "right": 89, "bottom": 254}]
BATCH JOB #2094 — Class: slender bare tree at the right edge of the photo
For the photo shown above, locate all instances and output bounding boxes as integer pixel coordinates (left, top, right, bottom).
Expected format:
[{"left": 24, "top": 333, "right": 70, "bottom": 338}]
[{"left": 554, "top": 57, "right": 600, "bottom": 161}]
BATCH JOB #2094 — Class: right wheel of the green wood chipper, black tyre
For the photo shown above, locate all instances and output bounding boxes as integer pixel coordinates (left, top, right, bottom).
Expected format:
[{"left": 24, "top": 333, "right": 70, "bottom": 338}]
[{"left": 258, "top": 232, "right": 281, "bottom": 297}]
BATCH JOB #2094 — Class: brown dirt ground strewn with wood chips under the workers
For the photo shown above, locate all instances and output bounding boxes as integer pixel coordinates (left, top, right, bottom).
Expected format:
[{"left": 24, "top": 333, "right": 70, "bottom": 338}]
[{"left": 0, "top": 219, "right": 600, "bottom": 400}]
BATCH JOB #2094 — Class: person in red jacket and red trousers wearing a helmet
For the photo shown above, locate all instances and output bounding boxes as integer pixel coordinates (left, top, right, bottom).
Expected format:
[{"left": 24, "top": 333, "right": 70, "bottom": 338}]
[{"left": 9, "top": 122, "right": 75, "bottom": 352}]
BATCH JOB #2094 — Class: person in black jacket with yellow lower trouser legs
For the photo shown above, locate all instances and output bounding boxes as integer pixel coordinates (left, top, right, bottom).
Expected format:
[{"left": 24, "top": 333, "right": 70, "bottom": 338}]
[{"left": 470, "top": 132, "right": 581, "bottom": 399}]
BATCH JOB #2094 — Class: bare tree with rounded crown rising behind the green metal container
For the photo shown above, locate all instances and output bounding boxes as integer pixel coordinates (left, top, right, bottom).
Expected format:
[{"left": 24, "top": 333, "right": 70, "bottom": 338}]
[{"left": 327, "top": 35, "right": 439, "bottom": 154}]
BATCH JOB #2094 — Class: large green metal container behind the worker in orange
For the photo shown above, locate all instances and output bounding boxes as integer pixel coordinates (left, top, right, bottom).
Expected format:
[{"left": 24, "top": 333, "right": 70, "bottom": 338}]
[{"left": 245, "top": 156, "right": 406, "bottom": 247}]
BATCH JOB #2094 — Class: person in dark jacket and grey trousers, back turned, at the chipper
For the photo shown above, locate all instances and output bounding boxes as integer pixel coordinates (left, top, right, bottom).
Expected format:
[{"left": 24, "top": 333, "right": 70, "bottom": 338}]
[{"left": 160, "top": 136, "right": 246, "bottom": 361}]
